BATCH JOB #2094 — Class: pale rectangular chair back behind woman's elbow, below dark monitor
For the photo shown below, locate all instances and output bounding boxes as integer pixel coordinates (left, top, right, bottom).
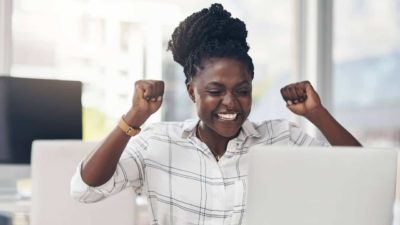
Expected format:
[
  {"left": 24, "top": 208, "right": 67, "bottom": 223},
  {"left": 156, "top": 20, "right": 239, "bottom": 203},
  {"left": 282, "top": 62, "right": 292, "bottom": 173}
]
[{"left": 30, "top": 140, "right": 137, "bottom": 225}]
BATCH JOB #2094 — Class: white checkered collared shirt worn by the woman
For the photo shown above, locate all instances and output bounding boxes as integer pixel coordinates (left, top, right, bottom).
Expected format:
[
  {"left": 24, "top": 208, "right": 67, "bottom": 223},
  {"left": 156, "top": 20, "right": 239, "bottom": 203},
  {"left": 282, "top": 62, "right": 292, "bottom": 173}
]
[{"left": 71, "top": 120, "right": 328, "bottom": 225}]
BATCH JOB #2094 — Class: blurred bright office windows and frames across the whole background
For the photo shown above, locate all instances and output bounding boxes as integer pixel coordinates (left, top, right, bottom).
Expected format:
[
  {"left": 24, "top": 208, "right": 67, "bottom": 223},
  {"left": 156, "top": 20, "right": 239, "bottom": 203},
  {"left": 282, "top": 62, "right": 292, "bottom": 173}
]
[{"left": 0, "top": 0, "right": 400, "bottom": 147}]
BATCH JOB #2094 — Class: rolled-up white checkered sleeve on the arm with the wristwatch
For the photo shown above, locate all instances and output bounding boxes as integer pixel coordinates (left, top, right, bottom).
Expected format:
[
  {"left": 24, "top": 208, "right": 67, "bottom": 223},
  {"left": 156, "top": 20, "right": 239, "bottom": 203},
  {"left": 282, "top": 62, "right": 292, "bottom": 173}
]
[{"left": 70, "top": 127, "right": 147, "bottom": 203}]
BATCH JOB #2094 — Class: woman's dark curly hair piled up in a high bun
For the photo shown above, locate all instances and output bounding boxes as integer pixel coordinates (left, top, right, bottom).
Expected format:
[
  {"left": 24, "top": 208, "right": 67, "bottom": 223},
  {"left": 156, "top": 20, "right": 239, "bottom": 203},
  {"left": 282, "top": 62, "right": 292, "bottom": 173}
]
[{"left": 168, "top": 3, "right": 254, "bottom": 83}]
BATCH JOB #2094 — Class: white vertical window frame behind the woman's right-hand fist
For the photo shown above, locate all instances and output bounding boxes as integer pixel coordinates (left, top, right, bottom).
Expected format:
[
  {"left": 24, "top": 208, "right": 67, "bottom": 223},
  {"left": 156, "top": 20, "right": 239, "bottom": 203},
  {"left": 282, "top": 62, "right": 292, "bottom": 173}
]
[{"left": 294, "top": 0, "right": 334, "bottom": 138}]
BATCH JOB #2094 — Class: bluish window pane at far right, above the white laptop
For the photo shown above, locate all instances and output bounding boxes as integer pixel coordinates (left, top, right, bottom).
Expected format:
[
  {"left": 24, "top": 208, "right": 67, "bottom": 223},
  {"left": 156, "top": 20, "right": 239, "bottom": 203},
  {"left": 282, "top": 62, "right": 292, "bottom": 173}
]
[{"left": 334, "top": 0, "right": 400, "bottom": 147}]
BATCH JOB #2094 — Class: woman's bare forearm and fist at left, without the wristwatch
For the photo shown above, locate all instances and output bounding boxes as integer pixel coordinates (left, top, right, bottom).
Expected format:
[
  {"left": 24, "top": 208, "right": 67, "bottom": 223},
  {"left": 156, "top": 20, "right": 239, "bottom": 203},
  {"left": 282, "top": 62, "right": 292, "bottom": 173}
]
[{"left": 81, "top": 80, "right": 164, "bottom": 187}]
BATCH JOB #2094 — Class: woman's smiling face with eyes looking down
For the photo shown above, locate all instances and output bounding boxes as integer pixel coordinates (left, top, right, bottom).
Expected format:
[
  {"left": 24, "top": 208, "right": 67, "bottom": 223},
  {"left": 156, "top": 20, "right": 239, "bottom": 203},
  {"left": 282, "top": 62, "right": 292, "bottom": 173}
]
[{"left": 187, "top": 58, "right": 252, "bottom": 138}]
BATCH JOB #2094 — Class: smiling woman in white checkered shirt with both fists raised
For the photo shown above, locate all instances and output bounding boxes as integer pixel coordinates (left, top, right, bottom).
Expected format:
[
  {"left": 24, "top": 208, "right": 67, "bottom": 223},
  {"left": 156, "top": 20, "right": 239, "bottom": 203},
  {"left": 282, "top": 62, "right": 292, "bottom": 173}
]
[{"left": 71, "top": 4, "right": 360, "bottom": 224}]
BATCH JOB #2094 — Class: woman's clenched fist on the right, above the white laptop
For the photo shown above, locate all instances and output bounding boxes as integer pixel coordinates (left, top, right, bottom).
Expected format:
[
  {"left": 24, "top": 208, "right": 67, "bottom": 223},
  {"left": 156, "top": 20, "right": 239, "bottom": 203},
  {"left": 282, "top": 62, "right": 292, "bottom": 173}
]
[{"left": 281, "top": 81, "right": 322, "bottom": 117}]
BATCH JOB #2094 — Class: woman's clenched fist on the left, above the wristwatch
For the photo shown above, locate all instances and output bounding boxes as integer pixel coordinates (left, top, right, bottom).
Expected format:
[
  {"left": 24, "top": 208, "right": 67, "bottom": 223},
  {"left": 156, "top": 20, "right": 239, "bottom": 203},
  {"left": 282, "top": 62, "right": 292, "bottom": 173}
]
[{"left": 132, "top": 80, "right": 164, "bottom": 120}]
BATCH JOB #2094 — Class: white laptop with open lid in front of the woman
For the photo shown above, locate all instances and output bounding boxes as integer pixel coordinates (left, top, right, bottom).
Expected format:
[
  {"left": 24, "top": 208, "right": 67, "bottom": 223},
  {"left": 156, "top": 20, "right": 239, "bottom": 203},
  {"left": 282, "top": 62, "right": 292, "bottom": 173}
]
[{"left": 245, "top": 146, "right": 397, "bottom": 225}]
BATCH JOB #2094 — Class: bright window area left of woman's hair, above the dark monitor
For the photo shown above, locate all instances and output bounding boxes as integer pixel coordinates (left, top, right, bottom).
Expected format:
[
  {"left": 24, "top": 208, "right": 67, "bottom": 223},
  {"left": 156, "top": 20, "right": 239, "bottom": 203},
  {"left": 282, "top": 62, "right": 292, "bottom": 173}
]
[{"left": 11, "top": 0, "right": 183, "bottom": 140}]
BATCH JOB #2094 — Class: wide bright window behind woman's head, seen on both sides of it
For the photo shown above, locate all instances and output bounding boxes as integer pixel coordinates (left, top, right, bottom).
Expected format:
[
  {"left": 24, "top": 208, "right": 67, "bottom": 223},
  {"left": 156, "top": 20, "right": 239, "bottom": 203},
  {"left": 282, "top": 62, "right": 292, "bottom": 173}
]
[{"left": 11, "top": 0, "right": 295, "bottom": 140}]
